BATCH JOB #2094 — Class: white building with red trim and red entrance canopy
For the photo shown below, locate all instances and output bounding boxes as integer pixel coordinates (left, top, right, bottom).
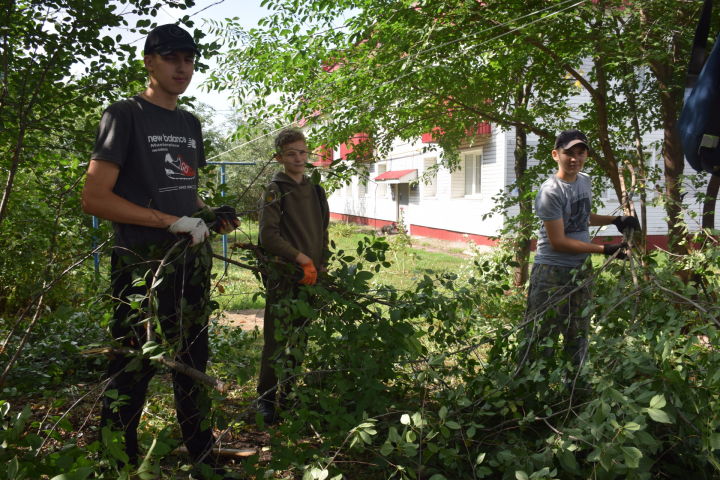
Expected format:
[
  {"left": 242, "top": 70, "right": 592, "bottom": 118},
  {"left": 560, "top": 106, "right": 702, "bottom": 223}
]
[{"left": 319, "top": 123, "right": 702, "bottom": 248}]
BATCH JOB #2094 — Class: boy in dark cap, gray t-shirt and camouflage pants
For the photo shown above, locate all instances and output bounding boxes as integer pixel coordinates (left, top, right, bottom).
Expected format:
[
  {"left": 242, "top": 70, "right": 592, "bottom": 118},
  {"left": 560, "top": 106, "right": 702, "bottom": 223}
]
[{"left": 520, "top": 130, "right": 640, "bottom": 378}]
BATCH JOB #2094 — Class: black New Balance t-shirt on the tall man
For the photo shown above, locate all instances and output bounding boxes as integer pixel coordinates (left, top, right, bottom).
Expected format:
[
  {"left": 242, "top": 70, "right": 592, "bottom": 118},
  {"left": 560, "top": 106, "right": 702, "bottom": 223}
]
[{"left": 91, "top": 96, "right": 205, "bottom": 248}]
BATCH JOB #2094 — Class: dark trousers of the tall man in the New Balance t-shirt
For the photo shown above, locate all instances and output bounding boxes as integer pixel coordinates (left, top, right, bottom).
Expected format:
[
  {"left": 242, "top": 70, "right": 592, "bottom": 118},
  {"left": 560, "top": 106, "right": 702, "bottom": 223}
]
[{"left": 101, "top": 246, "right": 214, "bottom": 463}]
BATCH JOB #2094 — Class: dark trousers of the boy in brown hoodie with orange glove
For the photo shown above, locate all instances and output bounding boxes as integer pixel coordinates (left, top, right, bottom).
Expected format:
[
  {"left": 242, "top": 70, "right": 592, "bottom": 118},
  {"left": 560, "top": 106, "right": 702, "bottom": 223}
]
[{"left": 257, "top": 276, "right": 308, "bottom": 404}]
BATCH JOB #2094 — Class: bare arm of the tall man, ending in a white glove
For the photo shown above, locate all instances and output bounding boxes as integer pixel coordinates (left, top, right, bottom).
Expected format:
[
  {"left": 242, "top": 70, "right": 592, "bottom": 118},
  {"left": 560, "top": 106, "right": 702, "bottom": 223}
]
[{"left": 82, "top": 159, "right": 179, "bottom": 228}]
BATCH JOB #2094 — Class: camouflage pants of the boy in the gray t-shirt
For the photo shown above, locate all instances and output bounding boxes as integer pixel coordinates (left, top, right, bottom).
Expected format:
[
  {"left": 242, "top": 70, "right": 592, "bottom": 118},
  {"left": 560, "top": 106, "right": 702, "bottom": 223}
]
[{"left": 519, "top": 263, "right": 592, "bottom": 367}]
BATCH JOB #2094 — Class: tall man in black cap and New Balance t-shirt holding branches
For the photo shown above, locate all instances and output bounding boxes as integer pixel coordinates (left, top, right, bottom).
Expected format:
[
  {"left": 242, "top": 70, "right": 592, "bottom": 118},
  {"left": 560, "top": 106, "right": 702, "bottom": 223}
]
[{"left": 82, "top": 25, "right": 238, "bottom": 476}]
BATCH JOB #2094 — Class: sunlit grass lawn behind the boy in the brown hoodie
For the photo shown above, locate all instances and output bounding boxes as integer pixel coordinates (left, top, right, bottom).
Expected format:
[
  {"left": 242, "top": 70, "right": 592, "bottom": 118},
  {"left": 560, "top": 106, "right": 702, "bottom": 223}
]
[{"left": 213, "top": 222, "right": 476, "bottom": 311}]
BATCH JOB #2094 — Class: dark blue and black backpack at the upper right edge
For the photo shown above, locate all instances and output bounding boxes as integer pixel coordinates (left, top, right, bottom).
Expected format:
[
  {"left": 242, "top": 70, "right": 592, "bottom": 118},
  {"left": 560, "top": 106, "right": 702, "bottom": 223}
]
[{"left": 678, "top": 0, "right": 720, "bottom": 175}]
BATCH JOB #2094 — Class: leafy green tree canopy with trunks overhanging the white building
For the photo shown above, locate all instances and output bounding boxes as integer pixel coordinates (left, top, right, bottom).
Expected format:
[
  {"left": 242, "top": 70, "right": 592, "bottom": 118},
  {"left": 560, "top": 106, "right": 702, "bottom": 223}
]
[{"left": 215, "top": 0, "right": 708, "bottom": 258}]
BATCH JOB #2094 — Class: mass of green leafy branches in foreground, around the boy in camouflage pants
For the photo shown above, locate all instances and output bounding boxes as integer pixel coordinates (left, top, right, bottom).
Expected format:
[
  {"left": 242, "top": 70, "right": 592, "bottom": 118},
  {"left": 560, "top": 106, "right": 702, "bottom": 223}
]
[{"left": 243, "top": 239, "right": 720, "bottom": 479}]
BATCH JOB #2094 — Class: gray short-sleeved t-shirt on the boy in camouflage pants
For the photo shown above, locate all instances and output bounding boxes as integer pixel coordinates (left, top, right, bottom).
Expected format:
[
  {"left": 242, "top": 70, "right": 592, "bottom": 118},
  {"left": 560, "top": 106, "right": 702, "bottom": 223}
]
[{"left": 535, "top": 173, "right": 592, "bottom": 267}]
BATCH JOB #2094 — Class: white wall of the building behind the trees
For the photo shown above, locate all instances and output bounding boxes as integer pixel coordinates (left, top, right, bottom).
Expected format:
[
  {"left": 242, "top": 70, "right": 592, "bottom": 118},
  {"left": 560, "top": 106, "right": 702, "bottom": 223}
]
[{"left": 329, "top": 125, "right": 720, "bottom": 236}]
